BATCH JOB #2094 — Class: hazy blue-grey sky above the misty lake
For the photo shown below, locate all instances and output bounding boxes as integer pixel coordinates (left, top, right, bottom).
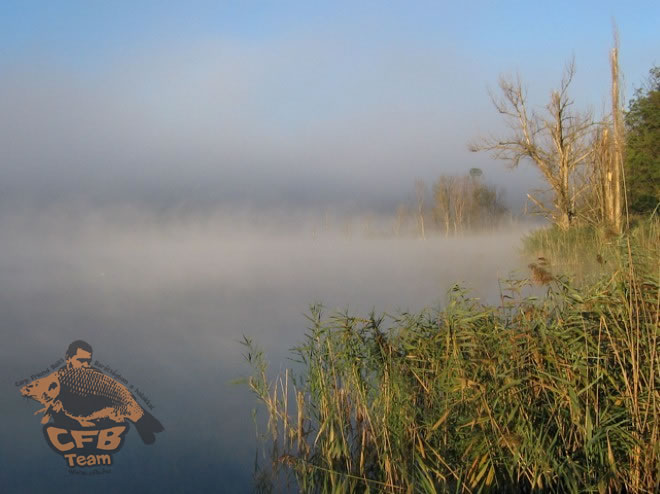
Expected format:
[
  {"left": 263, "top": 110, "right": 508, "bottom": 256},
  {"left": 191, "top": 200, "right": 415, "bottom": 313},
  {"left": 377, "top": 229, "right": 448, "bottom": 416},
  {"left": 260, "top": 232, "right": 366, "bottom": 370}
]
[{"left": 0, "top": 0, "right": 660, "bottom": 213}]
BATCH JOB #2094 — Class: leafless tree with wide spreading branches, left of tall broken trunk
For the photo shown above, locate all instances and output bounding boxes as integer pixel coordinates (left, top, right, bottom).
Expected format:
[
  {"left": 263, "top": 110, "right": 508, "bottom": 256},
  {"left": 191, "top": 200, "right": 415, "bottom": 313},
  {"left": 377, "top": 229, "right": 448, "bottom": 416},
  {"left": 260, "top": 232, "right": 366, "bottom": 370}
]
[{"left": 470, "top": 61, "right": 592, "bottom": 229}]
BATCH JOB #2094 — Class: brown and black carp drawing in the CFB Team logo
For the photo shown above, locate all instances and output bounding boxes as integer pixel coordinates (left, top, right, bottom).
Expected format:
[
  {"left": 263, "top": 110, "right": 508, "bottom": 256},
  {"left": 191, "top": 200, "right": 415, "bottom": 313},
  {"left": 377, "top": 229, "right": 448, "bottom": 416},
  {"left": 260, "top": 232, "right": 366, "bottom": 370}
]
[{"left": 21, "top": 366, "right": 164, "bottom": 444}]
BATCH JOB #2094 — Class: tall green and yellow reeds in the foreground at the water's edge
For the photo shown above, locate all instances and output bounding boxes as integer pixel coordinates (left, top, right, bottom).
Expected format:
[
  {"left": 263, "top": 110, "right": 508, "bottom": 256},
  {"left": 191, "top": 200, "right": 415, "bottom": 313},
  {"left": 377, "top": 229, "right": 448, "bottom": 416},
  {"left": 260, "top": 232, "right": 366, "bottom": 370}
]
[{"left": 245, "top": 227, "right": 660, "bottom": 493}]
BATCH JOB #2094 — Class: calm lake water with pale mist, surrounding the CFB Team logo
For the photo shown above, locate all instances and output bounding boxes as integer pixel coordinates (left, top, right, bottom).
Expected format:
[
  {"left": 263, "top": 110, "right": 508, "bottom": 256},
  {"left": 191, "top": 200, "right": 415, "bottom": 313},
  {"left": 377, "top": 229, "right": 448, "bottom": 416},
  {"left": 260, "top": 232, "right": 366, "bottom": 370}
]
[{"left": 0, "top": 209, "right": 524, "bottom": 492}]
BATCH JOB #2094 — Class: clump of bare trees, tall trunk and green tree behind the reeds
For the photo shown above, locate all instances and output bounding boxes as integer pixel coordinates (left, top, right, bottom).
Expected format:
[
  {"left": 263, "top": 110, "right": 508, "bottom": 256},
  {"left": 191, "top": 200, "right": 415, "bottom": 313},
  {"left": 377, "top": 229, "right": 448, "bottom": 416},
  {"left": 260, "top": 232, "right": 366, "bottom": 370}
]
[{"left": 470, "top": 33, "right": 660, "bottom": 233}]
